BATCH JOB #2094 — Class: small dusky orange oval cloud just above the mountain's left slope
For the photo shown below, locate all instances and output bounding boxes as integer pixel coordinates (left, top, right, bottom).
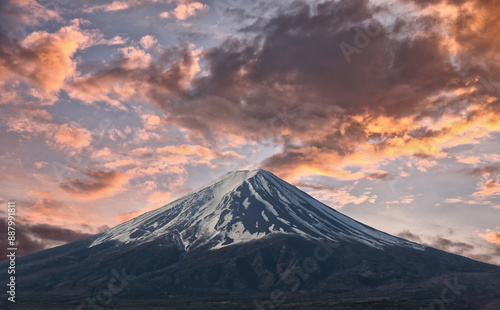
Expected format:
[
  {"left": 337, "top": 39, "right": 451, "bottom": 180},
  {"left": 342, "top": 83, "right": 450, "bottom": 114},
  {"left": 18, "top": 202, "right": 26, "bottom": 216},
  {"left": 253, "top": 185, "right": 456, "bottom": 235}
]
[{"left": 60, "top": 170, "right": 130, "bottom": 199}]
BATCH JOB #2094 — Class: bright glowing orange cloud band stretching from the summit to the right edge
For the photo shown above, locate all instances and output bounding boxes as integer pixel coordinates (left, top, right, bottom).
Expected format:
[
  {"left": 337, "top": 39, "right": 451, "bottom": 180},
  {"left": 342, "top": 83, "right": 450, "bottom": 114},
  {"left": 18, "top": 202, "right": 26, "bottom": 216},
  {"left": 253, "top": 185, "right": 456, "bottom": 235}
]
[{"left": 262, "top": 100, "right": 500, "bottom": 183}]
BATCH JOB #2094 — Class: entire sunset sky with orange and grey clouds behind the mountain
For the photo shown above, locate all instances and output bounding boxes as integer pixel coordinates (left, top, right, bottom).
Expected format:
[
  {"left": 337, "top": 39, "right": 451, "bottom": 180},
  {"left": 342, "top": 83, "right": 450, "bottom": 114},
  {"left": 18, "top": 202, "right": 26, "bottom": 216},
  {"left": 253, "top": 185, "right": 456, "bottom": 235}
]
[{"left": 0, "top": 0, "right": 500, "bottom": 264}]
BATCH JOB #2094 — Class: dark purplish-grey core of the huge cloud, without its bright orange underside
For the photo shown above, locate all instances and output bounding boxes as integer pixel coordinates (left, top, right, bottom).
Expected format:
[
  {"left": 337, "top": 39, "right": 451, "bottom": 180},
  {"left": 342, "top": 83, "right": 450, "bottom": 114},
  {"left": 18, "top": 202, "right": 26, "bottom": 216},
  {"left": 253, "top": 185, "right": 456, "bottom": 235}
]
[{"left": 174, "top": 0, "right": 457, "bottom": 131}]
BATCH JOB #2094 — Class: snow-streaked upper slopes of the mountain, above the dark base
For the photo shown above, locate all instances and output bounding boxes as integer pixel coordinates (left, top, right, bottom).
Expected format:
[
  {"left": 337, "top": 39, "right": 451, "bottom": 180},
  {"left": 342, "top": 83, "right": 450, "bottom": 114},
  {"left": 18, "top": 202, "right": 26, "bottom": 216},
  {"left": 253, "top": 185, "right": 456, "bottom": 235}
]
[{"left": 91, "top": 170, "right": 424, "bottom": 251}]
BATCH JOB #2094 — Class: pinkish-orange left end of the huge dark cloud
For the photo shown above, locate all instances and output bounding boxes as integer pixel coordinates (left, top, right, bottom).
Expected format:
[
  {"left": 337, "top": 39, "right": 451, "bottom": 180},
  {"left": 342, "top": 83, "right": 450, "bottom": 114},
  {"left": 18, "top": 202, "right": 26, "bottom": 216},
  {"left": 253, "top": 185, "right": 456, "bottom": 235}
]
[{"left": 70, "top": 41, "right": 201, "bottom": 107}]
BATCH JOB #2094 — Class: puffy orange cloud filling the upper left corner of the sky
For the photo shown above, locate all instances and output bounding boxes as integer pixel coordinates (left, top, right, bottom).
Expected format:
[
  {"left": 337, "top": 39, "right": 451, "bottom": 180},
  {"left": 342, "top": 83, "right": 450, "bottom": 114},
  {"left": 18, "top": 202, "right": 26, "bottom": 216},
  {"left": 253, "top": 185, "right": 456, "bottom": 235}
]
[{"left": 0, "top": 15, "right": 127, "bottom": 106}]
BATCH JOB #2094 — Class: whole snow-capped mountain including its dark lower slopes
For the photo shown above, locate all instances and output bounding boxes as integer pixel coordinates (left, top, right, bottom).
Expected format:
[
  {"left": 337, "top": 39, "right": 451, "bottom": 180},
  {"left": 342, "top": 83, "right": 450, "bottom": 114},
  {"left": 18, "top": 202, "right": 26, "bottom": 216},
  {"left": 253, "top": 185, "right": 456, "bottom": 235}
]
[{"left": 0, "top": 170, "right": 500, "bottom": 309}]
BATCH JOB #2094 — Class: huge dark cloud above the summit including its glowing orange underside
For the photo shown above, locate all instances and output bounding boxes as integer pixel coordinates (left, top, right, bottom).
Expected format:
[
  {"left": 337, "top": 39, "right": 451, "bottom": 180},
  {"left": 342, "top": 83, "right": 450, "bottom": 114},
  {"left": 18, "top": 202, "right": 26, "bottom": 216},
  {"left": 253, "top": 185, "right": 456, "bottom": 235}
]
[{"left": 77, "top": 1, "right": 488, "bottom": 180}]
